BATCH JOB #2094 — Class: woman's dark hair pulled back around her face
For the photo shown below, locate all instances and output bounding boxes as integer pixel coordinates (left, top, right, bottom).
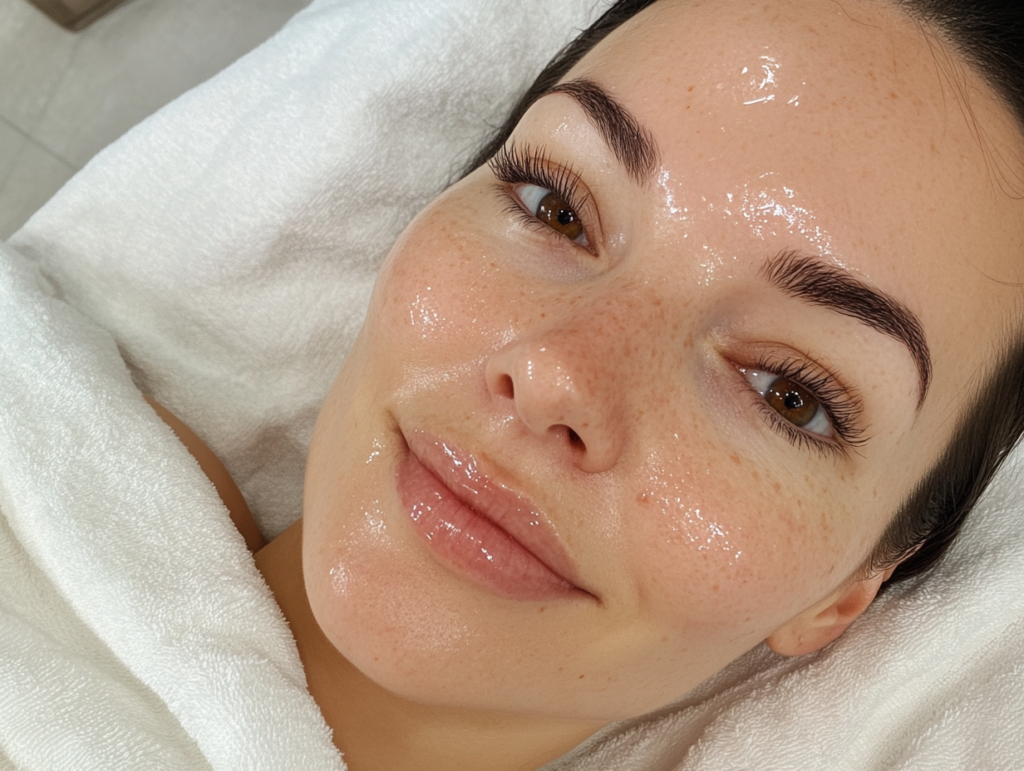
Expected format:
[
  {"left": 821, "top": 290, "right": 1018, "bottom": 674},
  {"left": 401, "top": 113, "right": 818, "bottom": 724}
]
[{"left": 466, "top": 0, "right": 1024, "bottom": 582}]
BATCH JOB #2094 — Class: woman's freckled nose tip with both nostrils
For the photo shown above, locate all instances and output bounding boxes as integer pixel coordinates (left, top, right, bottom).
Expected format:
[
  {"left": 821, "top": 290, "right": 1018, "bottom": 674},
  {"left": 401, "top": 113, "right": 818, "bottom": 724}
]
[{"left": 484, "top": 336, "right": 626, "bottom": 473}]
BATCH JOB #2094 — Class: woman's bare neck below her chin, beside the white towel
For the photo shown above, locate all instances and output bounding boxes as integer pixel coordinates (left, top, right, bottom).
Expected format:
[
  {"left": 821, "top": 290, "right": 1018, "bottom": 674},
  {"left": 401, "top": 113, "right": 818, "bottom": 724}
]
[{"left": 256, "top": 520, "right": 600, "bottom": 771}]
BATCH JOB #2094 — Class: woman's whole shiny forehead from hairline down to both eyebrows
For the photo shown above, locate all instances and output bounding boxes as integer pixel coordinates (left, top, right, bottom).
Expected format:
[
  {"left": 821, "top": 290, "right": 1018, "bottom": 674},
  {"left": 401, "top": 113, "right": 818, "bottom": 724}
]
[{"left": 568, "top": 0, "right": 1024, "bottom": 411}]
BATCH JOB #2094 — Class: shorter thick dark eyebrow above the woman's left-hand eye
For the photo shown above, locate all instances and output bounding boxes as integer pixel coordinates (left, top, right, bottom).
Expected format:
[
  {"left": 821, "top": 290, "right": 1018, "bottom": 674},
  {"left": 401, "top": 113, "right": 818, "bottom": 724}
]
[{"left": 545, "top": 78, "right": 658, "bottom": 184}]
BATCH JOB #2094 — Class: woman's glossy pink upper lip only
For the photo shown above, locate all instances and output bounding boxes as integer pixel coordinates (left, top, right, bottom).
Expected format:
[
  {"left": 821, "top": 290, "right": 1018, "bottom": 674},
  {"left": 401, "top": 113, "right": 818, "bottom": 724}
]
[{"left": 402, "top": 423, "right": 587, "bottom": 592}]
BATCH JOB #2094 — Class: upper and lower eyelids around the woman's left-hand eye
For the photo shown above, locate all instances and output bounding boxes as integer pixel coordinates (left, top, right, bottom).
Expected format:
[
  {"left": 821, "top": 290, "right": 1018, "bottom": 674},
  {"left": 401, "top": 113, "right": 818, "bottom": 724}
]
[{"left": 487, "top": 140, "right": 603, "bottom": 250}]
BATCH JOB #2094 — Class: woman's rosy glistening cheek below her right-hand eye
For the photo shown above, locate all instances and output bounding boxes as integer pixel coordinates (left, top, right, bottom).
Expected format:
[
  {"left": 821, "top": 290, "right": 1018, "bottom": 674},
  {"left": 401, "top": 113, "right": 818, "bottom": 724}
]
[{"left": 630, "top": 428, "right": 866, "bottom": 652}]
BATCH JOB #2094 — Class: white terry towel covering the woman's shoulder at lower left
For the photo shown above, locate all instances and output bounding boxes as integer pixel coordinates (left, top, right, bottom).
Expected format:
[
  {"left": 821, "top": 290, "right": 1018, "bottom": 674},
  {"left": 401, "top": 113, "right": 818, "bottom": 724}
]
[{"left": 0, "top": 245, "right": 343, "bottom": 771}]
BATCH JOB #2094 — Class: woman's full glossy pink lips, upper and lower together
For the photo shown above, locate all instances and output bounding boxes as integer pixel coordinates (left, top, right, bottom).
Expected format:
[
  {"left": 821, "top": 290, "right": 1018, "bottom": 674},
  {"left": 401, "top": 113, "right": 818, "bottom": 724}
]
[{"left": 395, "top": 431, "right": 592, "bottom": 601}]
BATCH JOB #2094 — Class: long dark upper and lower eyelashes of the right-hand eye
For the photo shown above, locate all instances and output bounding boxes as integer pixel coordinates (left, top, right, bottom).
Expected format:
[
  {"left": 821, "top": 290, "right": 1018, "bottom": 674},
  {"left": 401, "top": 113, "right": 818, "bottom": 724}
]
[{"left": 754, "top": 356, "right": 867, "bottom": 456}]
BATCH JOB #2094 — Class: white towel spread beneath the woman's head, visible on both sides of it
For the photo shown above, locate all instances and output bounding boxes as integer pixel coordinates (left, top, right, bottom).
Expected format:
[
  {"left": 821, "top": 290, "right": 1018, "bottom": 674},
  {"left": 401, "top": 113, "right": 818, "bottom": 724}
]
[{"left": 8, "top": 0, "right": 1024, "bottom": 771}]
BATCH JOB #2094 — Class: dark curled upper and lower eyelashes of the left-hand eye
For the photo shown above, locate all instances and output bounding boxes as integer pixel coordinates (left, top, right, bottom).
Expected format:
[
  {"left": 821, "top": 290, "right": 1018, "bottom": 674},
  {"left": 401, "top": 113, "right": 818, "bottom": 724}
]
[{"left": 487, "top": 141, "right": 590, "bottom": 243}]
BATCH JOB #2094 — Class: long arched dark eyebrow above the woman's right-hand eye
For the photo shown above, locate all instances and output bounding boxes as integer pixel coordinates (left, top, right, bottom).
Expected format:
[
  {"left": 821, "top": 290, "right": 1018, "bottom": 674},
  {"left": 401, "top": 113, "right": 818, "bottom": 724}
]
[{"left": 761, "top": 252, "right": 932, "bottom": 409}]
